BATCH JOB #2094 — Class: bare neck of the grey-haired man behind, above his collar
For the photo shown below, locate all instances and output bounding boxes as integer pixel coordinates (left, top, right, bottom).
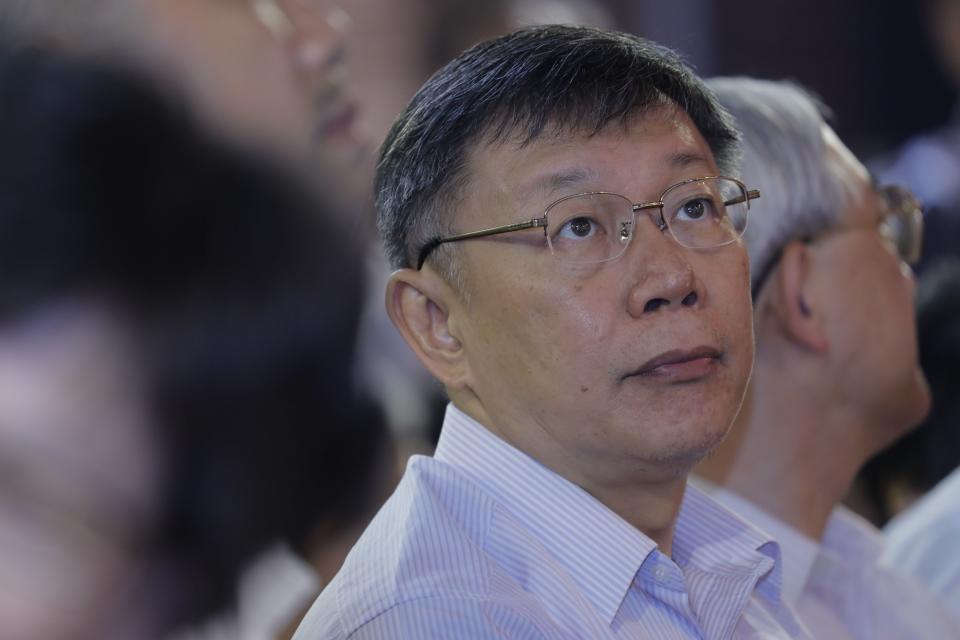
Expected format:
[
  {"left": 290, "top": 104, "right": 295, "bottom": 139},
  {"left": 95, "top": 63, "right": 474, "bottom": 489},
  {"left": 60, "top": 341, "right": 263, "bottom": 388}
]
[{"left": 697, "top": 359, "right": 872, "bottom": 540}]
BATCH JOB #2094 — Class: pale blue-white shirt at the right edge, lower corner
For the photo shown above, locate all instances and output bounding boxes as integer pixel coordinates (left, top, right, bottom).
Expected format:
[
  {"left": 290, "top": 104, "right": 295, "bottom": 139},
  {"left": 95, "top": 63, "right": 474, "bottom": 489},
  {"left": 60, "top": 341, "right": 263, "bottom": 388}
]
[{"left": 881, "top": 469, "right": 960, "bottom": 624}]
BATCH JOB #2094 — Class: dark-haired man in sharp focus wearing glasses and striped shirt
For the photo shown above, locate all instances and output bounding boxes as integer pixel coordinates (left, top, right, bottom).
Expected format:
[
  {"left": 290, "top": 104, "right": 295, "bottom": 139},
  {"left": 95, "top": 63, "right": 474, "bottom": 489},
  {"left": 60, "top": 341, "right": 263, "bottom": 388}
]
[{"left": 296, "top": 26, "right": 805, "bottom": 640}]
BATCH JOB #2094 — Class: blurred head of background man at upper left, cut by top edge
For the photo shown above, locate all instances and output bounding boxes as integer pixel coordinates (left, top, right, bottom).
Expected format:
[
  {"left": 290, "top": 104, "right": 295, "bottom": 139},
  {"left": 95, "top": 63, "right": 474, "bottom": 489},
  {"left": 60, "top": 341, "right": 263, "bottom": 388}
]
[{"left": 0, "top": 0, "right": 362, "bottom": 171}]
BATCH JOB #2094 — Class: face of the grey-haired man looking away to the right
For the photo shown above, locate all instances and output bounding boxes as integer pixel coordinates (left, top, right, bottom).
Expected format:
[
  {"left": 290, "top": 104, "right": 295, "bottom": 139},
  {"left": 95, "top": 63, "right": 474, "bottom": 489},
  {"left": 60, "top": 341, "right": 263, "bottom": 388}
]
[{"left": 813, "top": 126, "right": 930, "bottom": 444}]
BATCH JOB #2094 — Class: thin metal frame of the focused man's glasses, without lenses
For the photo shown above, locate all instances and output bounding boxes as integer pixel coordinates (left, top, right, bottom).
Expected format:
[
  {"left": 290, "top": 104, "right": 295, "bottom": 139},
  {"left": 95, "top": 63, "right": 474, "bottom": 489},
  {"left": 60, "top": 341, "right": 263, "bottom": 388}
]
[{"left": 417, "top": 176, "right": 760, "bottom": 271}]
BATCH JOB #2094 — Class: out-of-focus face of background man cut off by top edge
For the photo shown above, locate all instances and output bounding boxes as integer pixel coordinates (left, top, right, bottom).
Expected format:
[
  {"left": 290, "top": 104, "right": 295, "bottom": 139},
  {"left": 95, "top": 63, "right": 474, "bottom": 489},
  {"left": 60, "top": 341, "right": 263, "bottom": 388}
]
[{"left": 143, "top": 0, "right": 361, "bottom": 168}]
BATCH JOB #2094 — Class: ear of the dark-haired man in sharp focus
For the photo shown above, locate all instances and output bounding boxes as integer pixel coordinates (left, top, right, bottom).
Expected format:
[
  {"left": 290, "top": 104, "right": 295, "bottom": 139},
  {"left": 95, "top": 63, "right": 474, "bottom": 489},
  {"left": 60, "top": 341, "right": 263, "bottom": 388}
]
[{"left": 386, "top": 269, "right": 468, "bottom": 388}]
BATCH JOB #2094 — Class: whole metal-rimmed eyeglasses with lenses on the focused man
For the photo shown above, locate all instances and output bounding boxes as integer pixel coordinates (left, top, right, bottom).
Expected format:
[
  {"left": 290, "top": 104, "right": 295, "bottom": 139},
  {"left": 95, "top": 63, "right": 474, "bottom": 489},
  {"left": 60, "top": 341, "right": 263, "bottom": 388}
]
[{"left": 417, "top": 176, "right": 760, "bottom": 269}]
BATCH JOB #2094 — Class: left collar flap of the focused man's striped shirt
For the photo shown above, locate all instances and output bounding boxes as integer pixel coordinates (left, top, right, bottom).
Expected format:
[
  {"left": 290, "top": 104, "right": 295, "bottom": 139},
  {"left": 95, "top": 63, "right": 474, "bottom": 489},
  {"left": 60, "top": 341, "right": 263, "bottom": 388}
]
[{"left": 434, "top": 404, "right": 656, "bottom": 624}]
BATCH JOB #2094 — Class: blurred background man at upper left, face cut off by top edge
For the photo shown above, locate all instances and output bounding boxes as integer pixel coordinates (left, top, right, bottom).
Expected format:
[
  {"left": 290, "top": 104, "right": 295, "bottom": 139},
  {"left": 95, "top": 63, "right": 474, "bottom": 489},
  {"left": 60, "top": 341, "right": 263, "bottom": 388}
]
[{"left": 0, "top": 0, "right": 420, "bottom": 632}]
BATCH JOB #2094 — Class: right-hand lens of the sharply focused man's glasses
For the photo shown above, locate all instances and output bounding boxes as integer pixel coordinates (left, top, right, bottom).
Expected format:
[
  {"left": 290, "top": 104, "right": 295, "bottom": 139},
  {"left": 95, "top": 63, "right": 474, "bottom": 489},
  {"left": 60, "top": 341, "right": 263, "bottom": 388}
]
[{"left": 663, "top": 178, "right": 750, "bottom": 249}]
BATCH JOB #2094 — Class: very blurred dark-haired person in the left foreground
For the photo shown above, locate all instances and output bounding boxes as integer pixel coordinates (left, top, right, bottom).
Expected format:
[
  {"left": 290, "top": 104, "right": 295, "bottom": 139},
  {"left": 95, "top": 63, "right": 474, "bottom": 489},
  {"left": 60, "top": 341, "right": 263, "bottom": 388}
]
[{"left": 0, "top": 53, "right": 385, "bottom": 640}]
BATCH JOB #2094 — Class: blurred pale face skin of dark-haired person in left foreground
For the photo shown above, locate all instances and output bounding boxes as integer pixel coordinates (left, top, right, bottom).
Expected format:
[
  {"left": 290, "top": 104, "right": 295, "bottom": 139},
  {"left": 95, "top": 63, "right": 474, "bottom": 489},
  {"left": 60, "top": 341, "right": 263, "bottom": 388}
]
[{"left": 0, "top": 304, "right": 159, "bottom": 640}]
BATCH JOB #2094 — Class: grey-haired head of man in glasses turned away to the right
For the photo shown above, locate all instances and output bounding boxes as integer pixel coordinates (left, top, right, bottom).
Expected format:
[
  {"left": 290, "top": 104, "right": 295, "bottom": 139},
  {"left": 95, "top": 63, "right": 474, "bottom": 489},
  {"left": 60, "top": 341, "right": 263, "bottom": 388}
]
[{"left": 710, "top": 78, "right": 929, "bottom": 449}]
